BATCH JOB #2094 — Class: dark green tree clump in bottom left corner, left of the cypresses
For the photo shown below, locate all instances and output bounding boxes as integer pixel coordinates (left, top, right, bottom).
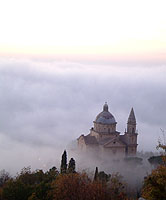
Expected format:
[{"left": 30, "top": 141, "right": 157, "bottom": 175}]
[{"left": 0, "top": 167, "right": 59, "bottom": 200}]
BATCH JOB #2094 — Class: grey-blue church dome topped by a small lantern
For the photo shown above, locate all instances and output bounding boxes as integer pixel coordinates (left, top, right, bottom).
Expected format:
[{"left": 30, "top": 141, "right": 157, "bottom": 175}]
[{"left": 95, "top": 103, "right": 116, "bottom": 124}]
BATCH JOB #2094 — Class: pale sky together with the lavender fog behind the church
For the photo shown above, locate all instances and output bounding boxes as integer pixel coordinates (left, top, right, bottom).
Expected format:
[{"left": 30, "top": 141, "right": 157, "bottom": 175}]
[{"left": 0, "top": 0, "right": 166, "bottom": 173}]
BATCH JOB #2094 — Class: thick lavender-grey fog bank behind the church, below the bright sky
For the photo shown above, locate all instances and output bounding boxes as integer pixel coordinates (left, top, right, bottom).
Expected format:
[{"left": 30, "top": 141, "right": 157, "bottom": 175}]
[{"left": 0, "top": 55, "right": 166, "bottom": 173}]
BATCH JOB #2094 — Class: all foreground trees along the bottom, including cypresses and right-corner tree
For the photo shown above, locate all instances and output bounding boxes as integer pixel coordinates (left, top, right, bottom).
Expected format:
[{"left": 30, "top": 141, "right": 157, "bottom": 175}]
[{"left": 0, "top": 151, "right": 166, "bottom": 200}]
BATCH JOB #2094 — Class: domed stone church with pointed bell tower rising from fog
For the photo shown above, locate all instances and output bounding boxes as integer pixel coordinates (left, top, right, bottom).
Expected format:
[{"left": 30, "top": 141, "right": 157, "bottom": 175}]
[{"left": 77, "top": 103, "right": 138, "bottom": 157}]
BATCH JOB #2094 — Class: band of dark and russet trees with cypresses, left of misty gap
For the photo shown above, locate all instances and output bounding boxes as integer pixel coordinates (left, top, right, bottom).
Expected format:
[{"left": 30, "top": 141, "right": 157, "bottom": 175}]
[{"left": 0, "top": 151, "right": 132, "bottom": 200}]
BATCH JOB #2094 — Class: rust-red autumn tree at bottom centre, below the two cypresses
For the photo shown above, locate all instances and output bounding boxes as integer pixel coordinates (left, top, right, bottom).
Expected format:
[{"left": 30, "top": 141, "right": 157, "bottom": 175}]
[{"left": 52, "top": 173, "right": 107, "bottom": 200}]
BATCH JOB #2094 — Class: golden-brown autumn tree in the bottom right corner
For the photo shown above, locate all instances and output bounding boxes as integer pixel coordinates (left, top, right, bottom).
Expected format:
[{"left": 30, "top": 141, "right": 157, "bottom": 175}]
[{"left": 142, "top": 165, "right": 166, "bottom": 200}]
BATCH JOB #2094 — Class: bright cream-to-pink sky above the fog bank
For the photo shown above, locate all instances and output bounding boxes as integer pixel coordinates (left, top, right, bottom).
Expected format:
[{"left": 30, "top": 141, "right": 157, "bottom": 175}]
[{"left": 0, "top": 0, "right": 166, "bottom": 61}]
